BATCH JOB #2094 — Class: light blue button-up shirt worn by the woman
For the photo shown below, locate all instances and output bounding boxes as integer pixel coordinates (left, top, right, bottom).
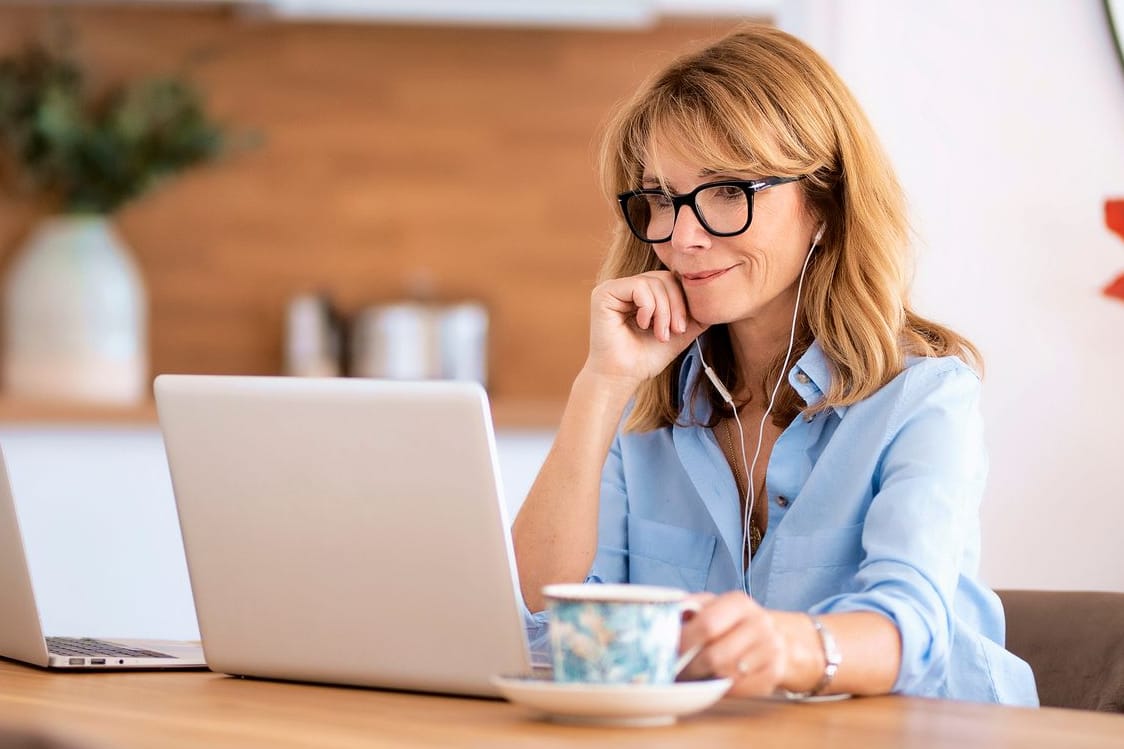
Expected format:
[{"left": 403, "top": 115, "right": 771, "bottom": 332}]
[{"left": 527, "top": 335, "right": 1037, "bottom": 705}]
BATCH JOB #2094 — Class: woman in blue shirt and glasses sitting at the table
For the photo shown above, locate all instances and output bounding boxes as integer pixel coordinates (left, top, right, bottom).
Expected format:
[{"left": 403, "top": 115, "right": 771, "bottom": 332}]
[{"left": 513, "top": 21, "right": 1037, "bottom": 704}]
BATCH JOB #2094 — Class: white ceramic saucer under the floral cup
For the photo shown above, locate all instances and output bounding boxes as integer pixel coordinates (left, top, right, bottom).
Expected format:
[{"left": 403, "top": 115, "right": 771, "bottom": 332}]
[{"left": 492, "top": 676, "right": 732, "bottom": 727}]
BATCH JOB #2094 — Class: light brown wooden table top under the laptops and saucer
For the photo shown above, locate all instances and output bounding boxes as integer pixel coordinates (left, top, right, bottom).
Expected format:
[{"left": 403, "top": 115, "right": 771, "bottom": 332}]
[{"left": 0, "top": 660, "right": 1124, "bottom": 749}]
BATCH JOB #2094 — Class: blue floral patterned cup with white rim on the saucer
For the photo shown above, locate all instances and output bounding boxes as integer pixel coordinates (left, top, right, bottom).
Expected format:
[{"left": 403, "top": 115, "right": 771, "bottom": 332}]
[{"left": 543, "top": 584, "right": 699, "bottom": 684}]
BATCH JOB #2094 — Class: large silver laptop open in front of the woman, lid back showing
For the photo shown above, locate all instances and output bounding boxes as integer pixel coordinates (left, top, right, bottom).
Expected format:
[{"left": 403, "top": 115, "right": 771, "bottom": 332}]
[{"left": 155, "top": 375, "right": 529, "bottom": 696}]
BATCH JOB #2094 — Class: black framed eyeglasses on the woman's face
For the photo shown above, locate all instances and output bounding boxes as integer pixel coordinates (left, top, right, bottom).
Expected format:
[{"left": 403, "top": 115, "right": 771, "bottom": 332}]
[{"left": 617, "top": 174, "right": 804, "bottom": 244}]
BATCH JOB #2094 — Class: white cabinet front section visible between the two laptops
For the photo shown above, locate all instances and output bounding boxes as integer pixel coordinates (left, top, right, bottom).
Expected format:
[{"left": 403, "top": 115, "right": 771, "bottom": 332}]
[{"left": 0, "top": 426, "right": 198, "bottom": 639}]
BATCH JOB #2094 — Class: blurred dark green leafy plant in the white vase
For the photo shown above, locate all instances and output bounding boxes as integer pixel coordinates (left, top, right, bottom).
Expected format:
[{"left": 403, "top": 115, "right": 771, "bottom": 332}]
[{"left": 0, "top": 46, "right": 226, "bottom": 214}]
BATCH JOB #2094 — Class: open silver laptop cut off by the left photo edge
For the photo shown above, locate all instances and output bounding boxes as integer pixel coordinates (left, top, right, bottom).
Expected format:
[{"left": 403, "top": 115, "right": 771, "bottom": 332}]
[{"left": 0, "top": 440, "right": 206, "bottom": 670}]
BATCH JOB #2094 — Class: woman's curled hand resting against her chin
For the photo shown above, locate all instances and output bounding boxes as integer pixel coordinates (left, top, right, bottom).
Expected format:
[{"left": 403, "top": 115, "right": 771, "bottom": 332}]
[{"left": 586, "top": 271, "right": 707, "bottom": 385}]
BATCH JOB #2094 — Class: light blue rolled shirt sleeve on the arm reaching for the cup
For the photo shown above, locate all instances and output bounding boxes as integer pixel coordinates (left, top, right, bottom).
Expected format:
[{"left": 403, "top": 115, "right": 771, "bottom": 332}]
[{"left": 813, "top": 364, "right": 987, "bottom": 693}]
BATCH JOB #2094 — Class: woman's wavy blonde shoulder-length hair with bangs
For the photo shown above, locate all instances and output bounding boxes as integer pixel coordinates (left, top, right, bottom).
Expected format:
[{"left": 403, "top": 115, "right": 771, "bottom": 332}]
[{"left": 600, "top": 25, "right": 981, "bottom": 431}]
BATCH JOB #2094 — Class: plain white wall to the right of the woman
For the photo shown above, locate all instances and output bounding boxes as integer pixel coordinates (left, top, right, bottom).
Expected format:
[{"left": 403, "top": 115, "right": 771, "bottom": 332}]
[{"left": 779, "top": 0, "right": 1124, "bottom": 590}]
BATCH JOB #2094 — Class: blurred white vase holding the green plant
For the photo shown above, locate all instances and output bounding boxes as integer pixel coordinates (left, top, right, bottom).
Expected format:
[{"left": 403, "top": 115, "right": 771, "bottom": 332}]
[{"left": 3, "top": 216, "right": 149, "bottom": 405}]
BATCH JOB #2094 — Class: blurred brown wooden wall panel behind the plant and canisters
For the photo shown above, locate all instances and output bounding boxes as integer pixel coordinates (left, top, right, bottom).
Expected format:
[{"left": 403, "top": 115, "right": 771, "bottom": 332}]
[{"left": 0, "top": 7, "right": 746, "bottom": 416}]
